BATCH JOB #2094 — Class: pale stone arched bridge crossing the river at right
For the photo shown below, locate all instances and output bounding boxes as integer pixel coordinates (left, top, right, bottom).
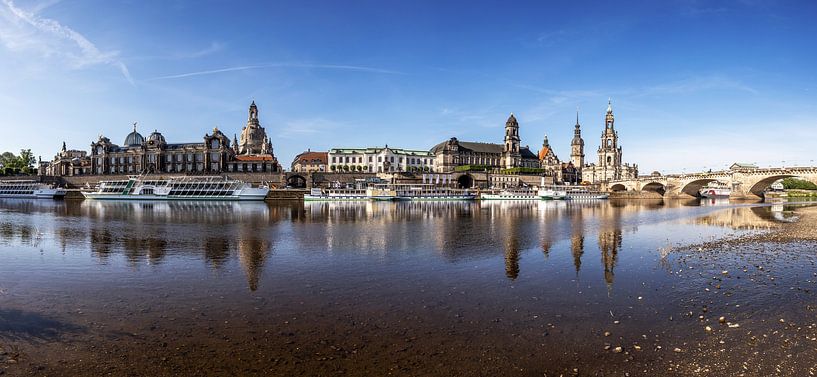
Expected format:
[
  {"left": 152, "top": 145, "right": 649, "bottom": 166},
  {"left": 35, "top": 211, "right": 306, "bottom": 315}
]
[{"left": 602, "top": 166, "right": 817, "bottom": 200}]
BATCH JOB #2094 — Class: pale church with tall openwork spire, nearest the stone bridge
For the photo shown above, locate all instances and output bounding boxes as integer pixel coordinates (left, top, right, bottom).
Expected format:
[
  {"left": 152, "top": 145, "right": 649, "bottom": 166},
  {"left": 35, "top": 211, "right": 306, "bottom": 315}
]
[{"left": 577, "top": 101, "right": 638, "bottom": 183}]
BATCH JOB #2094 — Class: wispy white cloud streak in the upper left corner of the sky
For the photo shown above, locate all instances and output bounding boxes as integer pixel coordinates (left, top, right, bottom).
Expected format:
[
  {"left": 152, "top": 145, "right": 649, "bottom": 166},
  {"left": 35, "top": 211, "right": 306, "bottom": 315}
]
[{"left": 0, "top": 0, "right": 134, "bottom": 84}]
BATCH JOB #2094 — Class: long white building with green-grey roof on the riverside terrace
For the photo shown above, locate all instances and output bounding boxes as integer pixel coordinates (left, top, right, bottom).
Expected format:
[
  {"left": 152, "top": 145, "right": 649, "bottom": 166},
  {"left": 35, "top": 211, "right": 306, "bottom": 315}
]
[{"left": 327, "top": 145, "right": 436, "bottom": 173}]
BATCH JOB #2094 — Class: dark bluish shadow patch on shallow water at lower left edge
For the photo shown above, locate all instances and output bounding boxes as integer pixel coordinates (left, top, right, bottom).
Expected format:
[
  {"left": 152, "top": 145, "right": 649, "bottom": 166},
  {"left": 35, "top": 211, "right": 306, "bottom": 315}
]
[{"left": 0, "top": 309, "right": 85, "bottom": 341}]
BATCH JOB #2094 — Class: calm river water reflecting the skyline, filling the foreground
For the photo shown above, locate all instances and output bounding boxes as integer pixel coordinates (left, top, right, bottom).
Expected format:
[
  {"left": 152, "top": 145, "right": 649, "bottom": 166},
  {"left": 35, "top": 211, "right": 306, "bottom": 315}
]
[{"left": 0, "top": 199, "right": 817, "bottom": 375}]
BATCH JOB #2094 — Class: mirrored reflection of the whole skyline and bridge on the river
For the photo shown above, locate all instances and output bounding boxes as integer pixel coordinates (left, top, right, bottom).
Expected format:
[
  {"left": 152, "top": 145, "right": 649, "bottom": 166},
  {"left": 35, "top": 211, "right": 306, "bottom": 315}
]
[{"left": 6, "top": 201, "right": 789, "bottom": 290}]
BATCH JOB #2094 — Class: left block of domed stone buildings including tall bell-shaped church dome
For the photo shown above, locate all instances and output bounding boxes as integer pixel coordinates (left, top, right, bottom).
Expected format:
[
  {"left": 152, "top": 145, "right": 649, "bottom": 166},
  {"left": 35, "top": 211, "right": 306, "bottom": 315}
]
[{"left": 43, "top": 102, "right": 280, "bottom": 175}]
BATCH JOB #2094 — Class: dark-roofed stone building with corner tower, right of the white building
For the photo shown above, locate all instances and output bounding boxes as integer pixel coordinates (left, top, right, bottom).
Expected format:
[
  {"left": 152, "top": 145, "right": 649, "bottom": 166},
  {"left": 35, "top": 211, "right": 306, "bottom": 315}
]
[{"left": 431, "top": 114, "right": 540, "bottom": 172}]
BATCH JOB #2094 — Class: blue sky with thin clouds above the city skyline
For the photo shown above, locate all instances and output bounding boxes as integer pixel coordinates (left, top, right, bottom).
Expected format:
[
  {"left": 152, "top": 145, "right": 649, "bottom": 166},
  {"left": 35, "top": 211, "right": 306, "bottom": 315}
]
[{"left": 0, "top": 0, "right": 817, "bottom": 173}]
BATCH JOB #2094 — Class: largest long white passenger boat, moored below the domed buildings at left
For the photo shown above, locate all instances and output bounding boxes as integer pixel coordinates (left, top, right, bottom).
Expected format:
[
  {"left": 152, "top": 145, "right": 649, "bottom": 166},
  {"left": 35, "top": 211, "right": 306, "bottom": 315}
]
[{"left": 82, "top": 176, "right": 269, "bottom": 200}]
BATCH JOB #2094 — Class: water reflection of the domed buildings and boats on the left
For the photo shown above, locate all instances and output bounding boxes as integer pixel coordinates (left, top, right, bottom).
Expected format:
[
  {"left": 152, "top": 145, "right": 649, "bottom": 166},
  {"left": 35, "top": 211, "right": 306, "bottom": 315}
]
[{"left": 8, "top": 200, "right": 278, "bottom": 290}]
